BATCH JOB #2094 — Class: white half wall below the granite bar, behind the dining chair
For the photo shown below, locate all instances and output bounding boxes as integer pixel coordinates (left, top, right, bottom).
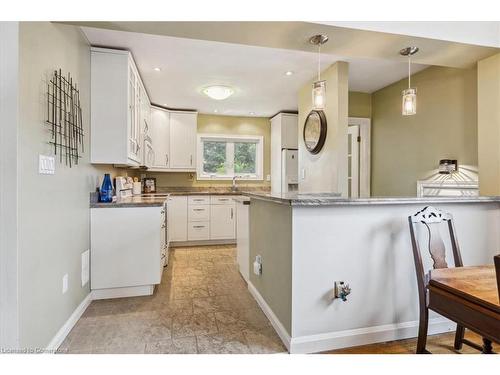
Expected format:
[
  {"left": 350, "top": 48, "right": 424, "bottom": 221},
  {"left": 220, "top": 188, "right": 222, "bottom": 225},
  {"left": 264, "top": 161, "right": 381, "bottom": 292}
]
[{"left": 291, "top": 203, "right": 500, "bottom": 352}]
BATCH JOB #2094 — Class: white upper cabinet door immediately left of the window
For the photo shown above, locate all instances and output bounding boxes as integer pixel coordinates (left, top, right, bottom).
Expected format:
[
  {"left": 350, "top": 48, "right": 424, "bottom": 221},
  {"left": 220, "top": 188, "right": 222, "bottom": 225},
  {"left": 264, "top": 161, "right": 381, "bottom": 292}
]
[{"left": 170, "top": 112, "right": 198, "bottom": 170}]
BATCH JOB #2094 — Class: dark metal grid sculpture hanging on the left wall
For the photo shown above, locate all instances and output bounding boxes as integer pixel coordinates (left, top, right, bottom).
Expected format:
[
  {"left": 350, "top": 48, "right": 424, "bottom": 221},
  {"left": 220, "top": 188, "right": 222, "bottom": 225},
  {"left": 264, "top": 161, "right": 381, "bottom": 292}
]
[{"left": 46, "top": 69, "right": 84, "bottom": 167}]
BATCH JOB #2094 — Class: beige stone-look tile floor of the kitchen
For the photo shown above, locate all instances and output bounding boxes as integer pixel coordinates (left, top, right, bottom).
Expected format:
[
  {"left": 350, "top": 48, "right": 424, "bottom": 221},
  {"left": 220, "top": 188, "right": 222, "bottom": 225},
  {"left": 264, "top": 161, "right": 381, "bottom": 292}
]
[{"left": 59, "top": 246, "right": 286, "bottom": 353}]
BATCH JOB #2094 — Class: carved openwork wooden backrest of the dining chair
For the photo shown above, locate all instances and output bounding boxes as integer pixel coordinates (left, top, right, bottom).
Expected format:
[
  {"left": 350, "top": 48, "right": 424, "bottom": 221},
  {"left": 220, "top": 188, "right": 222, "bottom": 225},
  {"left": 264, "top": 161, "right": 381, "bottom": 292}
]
[{"left": 408, "top": 206, "right": 463, "bottom": 303}]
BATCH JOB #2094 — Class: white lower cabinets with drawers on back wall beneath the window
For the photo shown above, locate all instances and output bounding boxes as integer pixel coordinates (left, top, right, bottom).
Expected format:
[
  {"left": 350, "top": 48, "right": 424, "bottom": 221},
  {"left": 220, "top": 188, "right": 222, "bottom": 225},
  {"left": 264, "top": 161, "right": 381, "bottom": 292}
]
[{"left": 167, "top": 195, "right": 236, "bottom": 242}]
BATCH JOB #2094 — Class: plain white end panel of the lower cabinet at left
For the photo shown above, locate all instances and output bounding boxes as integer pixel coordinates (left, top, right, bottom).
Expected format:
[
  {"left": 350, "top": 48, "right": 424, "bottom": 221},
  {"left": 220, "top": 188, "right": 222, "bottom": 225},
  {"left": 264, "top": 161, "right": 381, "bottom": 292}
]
[{"left": 90, "top": 207, "right": 165, "bottom": 299}]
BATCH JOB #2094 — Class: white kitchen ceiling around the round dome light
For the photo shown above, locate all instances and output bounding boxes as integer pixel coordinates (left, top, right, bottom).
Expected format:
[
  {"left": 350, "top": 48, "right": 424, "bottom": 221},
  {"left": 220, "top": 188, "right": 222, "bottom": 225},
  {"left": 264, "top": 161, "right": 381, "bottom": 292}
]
[{"left": 82, "top": 27, "right": 427, "bottom": 117}]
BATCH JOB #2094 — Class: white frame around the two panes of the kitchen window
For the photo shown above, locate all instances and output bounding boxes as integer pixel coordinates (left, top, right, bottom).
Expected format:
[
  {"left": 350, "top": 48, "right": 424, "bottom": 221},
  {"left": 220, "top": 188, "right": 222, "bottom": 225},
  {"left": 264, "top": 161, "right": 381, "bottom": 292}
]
[{"left": 196, "top": 134, "right": 264, "bottom": 181}]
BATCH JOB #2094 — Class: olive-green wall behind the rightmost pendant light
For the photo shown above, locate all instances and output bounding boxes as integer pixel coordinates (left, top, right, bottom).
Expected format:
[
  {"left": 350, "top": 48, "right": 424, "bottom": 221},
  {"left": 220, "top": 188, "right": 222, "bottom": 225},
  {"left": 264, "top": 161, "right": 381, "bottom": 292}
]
[{"left": 371, "top": 67, "right": 478, "bottom": 196}]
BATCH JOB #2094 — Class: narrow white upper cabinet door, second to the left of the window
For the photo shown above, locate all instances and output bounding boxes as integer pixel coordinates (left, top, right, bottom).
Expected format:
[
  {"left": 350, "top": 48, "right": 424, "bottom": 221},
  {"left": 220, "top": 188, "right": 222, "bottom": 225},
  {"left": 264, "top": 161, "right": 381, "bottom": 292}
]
[{"left": 149, "top": 108, "right": 170, "bottom": 169}]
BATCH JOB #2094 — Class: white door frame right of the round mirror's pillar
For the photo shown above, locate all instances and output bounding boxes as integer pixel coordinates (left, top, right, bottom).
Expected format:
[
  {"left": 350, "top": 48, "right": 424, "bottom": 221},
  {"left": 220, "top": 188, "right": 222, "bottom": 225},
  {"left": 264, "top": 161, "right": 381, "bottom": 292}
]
[{"left": 347, "top": 117, "right": 371, "bottom": 198}]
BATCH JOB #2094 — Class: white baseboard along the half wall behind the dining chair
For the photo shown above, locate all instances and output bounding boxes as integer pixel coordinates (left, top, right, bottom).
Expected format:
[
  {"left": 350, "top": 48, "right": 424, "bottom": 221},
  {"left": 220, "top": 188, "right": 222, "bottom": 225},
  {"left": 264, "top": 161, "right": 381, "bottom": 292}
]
[{"left": 289, "top": 317, "right": 456, "bottom": 353}]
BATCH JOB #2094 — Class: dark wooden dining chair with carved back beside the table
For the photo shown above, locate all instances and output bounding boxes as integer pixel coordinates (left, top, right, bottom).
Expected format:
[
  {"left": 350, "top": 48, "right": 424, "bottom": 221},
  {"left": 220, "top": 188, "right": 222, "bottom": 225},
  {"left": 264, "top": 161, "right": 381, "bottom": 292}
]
[{"left": 408, "top": 206, "right": 483, "bottom": 354}]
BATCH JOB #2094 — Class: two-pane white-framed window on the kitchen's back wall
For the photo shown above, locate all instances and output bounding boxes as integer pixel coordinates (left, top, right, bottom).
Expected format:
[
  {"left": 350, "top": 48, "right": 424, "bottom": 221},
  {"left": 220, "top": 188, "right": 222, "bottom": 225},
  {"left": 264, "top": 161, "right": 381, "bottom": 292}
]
[{"left": 197, "top": 134, "right": 264, "bottom": 180}]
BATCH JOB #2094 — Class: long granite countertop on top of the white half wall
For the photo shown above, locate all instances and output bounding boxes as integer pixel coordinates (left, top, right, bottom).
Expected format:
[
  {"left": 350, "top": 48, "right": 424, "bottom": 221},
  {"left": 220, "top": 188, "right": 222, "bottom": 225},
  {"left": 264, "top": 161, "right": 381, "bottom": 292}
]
[{"left": 245, "top": 192, "right": 500, "bottom": 206}]
